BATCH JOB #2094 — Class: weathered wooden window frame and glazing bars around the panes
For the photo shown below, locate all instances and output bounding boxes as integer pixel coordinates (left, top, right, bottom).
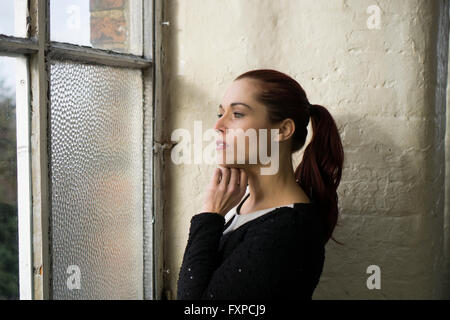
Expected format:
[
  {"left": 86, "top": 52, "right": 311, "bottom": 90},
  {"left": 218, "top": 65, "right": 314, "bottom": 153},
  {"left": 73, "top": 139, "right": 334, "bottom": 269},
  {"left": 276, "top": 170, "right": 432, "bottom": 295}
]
[{"left": 0, "top": 0, "right": 163, "bottom": 300}]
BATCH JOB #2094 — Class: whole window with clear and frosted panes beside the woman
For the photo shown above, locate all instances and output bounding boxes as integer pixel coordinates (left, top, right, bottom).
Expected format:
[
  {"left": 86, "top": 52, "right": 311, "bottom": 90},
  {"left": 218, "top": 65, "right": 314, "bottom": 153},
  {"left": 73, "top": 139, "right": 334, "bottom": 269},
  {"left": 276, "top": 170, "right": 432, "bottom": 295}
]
[{"left": 0, "top": 0, "right": 159, "bottom": 299}]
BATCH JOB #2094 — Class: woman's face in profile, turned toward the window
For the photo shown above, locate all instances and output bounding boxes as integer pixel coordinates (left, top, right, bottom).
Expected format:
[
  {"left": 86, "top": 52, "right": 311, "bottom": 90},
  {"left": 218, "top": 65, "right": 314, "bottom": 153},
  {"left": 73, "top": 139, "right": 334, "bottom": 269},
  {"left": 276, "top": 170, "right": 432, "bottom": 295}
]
[{"left": 214, "top": 79, "right": 274, "bottom": 168}]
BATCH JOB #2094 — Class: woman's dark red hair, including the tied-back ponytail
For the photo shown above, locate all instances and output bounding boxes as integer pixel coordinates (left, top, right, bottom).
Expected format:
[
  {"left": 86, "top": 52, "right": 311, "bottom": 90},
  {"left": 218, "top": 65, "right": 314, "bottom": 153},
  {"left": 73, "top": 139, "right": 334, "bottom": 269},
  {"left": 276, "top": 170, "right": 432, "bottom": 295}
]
[{"left": 235, "top": 69, "right": 344, "bottom": 243}]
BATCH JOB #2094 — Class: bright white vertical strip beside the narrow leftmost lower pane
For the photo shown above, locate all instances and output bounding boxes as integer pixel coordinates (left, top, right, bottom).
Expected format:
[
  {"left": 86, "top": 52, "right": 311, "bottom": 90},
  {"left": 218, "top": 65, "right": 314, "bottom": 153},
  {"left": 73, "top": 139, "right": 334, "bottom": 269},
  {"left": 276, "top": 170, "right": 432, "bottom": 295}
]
[{"left": 16, "top": 57, "right": 33, "bottom": 300}]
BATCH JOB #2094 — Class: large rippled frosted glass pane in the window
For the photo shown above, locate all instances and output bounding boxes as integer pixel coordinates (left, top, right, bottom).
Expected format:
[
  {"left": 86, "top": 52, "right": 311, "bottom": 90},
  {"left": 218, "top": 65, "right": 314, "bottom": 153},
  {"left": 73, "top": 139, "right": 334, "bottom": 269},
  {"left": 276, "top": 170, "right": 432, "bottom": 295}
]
[{"left": 50, "top": 62, "right": 143, "bottom": 299}]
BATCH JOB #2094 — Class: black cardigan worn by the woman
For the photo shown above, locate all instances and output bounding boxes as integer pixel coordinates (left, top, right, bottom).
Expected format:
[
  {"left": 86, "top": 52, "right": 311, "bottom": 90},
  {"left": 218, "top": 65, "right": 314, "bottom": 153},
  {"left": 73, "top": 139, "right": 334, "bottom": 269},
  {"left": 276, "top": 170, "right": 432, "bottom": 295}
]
[{"left": 177, "top": 202, "right": 325, "bottom": 300}]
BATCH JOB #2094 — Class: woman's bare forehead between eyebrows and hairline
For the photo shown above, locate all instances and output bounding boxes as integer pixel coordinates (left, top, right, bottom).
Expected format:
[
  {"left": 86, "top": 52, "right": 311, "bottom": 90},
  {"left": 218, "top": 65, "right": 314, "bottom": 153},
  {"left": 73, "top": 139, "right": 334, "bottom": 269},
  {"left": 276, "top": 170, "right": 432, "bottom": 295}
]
[{"left": 221, "top": 79, "right": 259, "bottom": 108}]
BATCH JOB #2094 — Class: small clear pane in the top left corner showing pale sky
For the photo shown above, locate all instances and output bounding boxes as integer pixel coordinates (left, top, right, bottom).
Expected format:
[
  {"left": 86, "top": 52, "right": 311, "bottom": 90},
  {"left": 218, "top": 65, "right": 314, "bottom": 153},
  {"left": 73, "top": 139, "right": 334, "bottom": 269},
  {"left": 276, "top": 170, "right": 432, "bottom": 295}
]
[{"left": 0, "top": 0, "right": 27, "bottom": 37}]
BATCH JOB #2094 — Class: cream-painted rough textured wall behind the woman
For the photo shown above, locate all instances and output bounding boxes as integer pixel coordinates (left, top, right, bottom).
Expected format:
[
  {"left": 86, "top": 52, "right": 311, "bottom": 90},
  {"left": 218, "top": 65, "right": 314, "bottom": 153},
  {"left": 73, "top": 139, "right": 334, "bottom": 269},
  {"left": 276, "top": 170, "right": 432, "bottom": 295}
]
[{"left": 163, "top": 0, "right": 448, "bottom": 299}]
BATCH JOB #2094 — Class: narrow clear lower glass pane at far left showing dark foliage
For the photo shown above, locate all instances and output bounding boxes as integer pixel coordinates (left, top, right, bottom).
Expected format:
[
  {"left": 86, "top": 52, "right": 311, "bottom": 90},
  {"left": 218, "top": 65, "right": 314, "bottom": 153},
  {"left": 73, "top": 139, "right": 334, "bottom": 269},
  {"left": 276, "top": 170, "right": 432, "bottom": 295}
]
[{"left": 0, "top": 56, "right": 19, "bottom": 300}]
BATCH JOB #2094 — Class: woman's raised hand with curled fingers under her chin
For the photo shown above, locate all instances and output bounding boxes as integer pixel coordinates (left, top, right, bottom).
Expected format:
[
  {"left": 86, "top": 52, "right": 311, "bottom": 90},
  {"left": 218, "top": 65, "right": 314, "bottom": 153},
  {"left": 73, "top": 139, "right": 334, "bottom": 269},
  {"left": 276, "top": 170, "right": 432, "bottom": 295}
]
[{"left": 202, "top": 167, "right": 247, "bottom": 217}]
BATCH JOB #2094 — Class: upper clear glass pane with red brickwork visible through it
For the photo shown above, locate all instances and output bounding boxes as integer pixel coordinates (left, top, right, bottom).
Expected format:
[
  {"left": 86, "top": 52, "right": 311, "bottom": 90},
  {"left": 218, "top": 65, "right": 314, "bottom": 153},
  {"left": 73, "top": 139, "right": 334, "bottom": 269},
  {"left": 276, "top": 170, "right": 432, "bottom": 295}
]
[{"left": 50, "top": 0, "right": 142, "bottom": 55}]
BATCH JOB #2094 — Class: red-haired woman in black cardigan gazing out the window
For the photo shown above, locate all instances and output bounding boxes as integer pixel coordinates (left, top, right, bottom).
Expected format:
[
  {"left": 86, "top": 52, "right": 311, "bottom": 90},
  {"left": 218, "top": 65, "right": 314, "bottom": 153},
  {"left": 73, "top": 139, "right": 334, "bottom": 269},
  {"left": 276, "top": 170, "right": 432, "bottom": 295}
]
[{"left": 177, "top": 69, "right": 344, "bottom": 300}]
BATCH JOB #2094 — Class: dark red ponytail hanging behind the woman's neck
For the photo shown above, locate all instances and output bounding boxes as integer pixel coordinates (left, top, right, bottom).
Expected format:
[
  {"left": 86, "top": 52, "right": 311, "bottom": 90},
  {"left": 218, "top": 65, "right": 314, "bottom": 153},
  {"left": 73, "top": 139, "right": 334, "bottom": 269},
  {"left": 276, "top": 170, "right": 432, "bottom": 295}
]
[{"left": 295, "top": 105, "right": 344, "bottom": 244}]
